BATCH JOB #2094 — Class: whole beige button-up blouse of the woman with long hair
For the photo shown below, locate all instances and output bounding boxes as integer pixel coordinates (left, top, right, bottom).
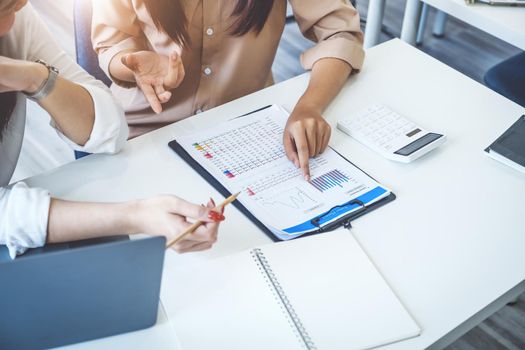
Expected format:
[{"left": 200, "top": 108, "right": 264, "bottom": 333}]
[{"left": 92, "top": 0, "right": 364, "bottom": 137}]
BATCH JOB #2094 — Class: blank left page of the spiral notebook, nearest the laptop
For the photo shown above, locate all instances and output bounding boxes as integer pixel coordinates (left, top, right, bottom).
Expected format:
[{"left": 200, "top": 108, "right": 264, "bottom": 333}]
[{"left": 160, "top": 251, "right": 304, "bottom": 350}]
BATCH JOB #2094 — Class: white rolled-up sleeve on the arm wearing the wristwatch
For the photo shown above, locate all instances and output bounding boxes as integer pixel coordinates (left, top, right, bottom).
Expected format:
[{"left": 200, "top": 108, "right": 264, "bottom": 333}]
[{"left": 23, "top": 5, "right": 128, "bottom": 153}]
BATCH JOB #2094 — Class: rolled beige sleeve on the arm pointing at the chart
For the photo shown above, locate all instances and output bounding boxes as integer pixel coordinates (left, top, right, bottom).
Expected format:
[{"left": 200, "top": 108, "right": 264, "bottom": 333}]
[{"left": 290, "top": 0, "right": 365, "bottom": 70}]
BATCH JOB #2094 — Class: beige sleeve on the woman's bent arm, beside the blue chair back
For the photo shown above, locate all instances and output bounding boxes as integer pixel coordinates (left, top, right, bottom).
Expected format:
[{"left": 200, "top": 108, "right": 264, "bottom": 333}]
[{"left": 91, "top": 0, "right": 149, "bottom": 87}]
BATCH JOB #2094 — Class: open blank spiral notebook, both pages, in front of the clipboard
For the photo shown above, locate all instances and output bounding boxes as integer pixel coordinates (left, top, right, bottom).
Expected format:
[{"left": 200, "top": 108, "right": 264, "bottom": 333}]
[{"left": 161, "top": 229, "right": 420, "bottom": 350}]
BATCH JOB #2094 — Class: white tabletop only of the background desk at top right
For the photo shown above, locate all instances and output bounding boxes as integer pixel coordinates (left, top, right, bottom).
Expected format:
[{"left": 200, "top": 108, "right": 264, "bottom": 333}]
[{"left": 422, "top": 0, "right": 525, "bottom": 50}]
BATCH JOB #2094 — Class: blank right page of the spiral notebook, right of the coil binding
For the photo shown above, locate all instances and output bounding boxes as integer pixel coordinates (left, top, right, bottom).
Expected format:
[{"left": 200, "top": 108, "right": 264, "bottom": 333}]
[{"left": 261, "top": 230, "right": 420, "bottom": 350}]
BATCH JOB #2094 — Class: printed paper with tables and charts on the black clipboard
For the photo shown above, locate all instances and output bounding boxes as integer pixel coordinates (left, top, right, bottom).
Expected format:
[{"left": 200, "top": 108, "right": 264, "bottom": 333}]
[{"left": 176, "top": 105, "right": 390, "bottom": 240}]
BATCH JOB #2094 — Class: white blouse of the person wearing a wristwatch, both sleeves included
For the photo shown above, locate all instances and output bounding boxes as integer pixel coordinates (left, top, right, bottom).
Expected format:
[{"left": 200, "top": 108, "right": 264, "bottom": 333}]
[{"left": 0, "top": 4, "right": 128, "bottom": 258}]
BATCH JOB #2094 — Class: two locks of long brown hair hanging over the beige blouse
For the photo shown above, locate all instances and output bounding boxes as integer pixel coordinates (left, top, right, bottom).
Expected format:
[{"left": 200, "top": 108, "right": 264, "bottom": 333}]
[{"left": 144, "top": 0, "right": 274, "bottom": 47}]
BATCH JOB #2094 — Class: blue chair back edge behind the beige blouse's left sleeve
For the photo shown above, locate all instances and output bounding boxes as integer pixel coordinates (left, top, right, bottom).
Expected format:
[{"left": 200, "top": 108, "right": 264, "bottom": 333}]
[{"left": 73, "top": 0, "right": 111, "bottom": 86}]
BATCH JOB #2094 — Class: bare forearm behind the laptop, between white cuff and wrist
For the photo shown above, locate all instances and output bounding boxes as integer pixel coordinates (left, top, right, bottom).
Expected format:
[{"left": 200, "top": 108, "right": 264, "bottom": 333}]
[{"left": 47, "top": 199, "right": 139, "bottom": 243}]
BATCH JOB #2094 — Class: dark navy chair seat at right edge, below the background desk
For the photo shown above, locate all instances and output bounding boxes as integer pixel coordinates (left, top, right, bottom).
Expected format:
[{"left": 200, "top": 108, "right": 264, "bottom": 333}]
[{"left": 484, "top": 51, "right": 525, "bottom": 107}]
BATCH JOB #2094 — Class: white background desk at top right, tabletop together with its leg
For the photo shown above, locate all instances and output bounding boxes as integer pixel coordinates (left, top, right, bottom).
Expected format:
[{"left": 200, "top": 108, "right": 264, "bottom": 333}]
[{"left": 398, "top": 0, "right": 525, "bottom": 50}]
